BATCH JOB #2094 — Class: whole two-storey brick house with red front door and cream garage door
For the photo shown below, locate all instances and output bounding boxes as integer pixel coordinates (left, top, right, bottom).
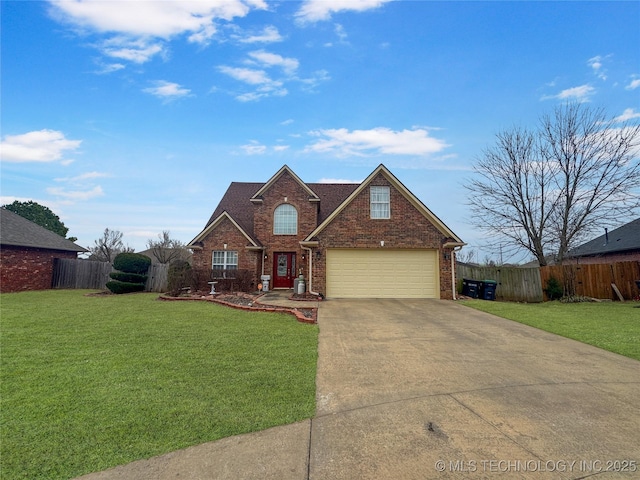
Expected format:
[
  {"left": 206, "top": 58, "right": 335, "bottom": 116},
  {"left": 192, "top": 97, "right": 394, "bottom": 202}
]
[{"left": 187, "top": 165, "right": 464, "bottom": 299}]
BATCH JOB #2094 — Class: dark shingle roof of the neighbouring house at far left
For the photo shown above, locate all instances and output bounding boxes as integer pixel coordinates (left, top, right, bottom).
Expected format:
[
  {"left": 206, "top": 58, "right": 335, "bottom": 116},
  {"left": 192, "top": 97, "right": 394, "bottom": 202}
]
[{"left": 0, "top": 208, "right": 87, "bottom": 252}]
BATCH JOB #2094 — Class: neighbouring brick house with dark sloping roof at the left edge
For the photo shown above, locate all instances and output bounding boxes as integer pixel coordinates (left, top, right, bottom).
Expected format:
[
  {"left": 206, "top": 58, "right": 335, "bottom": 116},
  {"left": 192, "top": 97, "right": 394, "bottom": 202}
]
[{"left": 0, "top": 208, "right": 87, "bottom": 293}]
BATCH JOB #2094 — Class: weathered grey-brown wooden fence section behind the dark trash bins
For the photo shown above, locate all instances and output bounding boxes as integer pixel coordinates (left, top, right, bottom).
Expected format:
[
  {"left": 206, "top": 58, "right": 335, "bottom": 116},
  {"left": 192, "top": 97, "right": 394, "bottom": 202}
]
[{"left": 456, "top": 263, "right": 543, "bottom": 303}]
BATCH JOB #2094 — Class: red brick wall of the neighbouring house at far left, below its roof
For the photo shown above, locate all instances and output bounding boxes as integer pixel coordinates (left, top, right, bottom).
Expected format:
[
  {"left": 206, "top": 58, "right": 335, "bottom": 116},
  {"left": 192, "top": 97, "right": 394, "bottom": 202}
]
[{"left": 0, "top": 245, "right": 78, "bottom": 292}]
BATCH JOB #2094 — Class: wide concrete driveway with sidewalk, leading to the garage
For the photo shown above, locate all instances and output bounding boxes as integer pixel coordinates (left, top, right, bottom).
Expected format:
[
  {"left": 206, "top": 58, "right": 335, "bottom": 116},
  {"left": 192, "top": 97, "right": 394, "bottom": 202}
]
[{"left": 82, "top": 300, "right": 640, "bottom": 480}]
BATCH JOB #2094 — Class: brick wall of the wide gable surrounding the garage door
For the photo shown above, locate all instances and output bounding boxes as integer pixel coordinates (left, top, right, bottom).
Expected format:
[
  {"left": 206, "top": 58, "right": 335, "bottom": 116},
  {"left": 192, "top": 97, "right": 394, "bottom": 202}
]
[{"left": 312, "top": 174, "right": 453, "bottom": 299}]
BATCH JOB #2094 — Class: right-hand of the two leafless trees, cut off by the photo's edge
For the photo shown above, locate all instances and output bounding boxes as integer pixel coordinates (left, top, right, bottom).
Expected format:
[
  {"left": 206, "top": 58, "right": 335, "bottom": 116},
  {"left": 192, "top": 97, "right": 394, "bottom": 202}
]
[{"left": 541, "top": 104, "right": 640, "bottom": 263}]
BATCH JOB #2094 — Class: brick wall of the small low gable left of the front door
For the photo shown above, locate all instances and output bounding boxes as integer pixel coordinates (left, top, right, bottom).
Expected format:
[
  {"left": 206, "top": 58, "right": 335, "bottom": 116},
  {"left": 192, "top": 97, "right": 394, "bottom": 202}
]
[{"left": 191, "top": 218, "right": 262, "bottom": 290}]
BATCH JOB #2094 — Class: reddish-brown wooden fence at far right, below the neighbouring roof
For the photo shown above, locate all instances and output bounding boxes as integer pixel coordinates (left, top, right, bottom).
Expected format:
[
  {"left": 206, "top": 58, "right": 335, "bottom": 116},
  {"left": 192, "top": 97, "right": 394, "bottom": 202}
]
[{"left": 540, "top": 261, "right": 640, "bottom": 300}]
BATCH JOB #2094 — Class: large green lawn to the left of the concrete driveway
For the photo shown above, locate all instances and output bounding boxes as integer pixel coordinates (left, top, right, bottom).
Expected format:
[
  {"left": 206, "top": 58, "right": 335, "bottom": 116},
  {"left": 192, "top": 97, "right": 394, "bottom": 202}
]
[{"left": 0, "top": 290, "right": 318, "bottom": 479}]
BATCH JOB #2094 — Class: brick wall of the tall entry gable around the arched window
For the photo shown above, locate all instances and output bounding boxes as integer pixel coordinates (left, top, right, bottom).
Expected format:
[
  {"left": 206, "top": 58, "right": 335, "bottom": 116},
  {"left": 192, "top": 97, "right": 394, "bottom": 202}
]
[{"left": 254, "top": 172, "right": 318, "bottom": 278}]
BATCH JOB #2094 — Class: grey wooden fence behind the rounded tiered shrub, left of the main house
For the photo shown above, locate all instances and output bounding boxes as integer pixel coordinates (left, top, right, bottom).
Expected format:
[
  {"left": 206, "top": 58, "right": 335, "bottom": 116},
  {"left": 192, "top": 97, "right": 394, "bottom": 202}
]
[{"left": 51, "top": 258, "right": 169, "bottom": 292}]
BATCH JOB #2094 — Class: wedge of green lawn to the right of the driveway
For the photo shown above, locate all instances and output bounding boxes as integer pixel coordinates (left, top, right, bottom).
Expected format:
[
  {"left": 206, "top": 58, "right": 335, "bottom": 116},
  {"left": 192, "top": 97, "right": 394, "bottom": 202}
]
[{"left": 461, "top": 300, "right": 640, "bottom": 360}]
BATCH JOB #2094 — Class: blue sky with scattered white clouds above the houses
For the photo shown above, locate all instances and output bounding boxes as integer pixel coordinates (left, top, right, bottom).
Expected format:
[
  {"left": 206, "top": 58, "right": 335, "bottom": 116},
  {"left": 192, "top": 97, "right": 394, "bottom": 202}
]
[{"left": 0, "top": 0, "right": 640, "bottom": 258}]
